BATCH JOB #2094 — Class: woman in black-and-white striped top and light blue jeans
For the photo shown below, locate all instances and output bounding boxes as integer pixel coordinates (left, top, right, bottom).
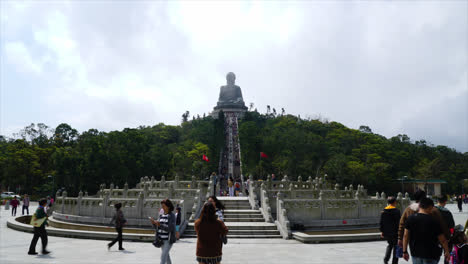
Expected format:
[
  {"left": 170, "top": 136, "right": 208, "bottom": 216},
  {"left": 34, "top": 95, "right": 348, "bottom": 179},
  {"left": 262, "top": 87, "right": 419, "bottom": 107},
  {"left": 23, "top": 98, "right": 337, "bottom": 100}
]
[{"left": 150, "top": 199, "right": 177, "bottom": 264}]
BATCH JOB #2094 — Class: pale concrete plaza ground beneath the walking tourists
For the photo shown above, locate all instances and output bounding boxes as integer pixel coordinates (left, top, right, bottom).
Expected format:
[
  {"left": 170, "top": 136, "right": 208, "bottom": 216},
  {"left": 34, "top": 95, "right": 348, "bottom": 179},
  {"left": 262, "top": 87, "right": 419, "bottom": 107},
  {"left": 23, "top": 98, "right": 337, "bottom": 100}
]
[{"left": 0, "top": 203, "right": 468, "bottom": 264}]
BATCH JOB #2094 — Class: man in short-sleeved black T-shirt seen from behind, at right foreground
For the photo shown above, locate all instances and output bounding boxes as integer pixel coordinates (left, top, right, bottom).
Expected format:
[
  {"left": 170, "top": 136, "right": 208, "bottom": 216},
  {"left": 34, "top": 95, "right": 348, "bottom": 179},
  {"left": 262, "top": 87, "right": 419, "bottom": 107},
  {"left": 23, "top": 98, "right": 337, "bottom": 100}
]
[{"left": 403, "top": 197, "right": 450, "bottom": 264}]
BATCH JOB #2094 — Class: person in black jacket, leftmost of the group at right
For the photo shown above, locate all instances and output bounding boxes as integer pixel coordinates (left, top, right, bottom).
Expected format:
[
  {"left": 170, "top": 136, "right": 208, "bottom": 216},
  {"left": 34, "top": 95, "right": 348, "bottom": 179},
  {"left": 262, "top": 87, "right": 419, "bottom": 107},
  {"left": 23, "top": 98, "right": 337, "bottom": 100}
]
[{"left": 380, "top": 196, "right": 401, "bottom": 264}]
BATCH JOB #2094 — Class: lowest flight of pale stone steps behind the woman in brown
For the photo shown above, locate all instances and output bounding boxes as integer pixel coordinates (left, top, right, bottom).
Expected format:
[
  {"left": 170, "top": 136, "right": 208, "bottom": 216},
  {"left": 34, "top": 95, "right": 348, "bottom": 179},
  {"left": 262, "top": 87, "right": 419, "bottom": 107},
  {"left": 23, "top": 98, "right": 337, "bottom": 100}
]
[{"left": 183, "top": 197, "right": 282, "bottom": 238}]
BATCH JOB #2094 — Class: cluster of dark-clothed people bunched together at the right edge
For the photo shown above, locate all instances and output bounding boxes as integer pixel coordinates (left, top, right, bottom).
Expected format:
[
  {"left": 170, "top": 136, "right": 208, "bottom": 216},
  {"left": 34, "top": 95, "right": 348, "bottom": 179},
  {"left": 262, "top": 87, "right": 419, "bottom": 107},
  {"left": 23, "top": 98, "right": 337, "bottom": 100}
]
[{"left": 380, "top": 190, "right": 468, "bottom": 264}]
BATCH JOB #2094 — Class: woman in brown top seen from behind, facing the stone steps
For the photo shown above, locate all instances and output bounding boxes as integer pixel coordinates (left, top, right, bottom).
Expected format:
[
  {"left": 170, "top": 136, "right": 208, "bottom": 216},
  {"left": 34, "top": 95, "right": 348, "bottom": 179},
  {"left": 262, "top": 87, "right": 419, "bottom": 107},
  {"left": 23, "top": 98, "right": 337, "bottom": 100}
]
[{"left": 195, "top": 203, "right": 228, "bottom": 264}]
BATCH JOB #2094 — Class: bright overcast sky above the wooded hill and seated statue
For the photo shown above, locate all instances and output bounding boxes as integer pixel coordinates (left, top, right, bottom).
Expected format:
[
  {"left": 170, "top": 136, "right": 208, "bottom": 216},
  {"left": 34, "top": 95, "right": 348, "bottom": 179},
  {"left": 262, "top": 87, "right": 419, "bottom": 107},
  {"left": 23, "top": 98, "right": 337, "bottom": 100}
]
[{"left": 0, "top": 0, "right": 468, "bottom": 152}]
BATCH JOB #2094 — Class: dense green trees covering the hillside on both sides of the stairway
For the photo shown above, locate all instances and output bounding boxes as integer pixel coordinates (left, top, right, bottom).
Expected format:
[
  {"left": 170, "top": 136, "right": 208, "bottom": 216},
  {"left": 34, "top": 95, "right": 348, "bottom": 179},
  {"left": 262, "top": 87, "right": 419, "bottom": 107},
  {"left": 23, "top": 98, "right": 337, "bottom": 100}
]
[{"left": 0, "top": 110, "right": 468, "bottom": 195}]
